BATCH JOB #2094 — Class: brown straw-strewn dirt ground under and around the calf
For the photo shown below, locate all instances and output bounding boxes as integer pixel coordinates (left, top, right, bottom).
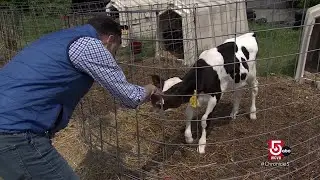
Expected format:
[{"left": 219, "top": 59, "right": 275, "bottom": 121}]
[{"left": 54, "top": 60, "right": 320, "bottom": 180}]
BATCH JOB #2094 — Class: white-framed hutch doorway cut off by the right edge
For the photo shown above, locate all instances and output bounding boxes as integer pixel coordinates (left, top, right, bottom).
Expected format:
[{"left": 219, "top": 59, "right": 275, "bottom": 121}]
[{"left": 295, "top": 4, "right": 320, "bottom": 84}]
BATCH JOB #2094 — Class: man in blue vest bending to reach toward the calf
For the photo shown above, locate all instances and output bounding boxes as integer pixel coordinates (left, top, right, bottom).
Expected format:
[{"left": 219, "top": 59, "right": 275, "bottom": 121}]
[{"left": 0, "top": 15, "right": 157, "bottom": 180}]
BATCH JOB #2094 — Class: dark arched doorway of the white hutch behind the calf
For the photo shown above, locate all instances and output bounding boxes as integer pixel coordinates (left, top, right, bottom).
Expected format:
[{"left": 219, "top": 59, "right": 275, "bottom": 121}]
[{"left": 159, "top": 10, "right": 184, "bottom": 59}]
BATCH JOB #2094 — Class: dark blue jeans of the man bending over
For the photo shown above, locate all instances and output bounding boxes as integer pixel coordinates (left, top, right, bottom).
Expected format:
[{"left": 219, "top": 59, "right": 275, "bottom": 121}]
[{"left": 0, "top": 132, "right": 79, "bottom": 180}]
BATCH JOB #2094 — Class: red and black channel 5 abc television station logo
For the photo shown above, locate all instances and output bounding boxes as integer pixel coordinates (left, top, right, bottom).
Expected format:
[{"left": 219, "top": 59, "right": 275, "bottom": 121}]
[{"left": 268, "top": 140, "right": 291, "bottom": 161}]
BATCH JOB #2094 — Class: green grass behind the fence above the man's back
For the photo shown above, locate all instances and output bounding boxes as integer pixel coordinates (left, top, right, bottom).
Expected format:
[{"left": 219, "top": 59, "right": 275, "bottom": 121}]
[{"left": 0, "top": 0, "right": 71, "bottom": 49}]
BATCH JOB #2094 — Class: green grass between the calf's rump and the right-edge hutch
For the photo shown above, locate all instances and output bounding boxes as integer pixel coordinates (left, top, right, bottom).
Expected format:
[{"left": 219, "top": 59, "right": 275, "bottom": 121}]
[{"left": 249, "top": 24, "right": 300, "bottom": 77}]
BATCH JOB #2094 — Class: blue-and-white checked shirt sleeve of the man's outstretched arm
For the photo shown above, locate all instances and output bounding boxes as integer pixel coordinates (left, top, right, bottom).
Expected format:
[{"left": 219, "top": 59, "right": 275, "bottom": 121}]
[{"left": 69, "top": 37, "right": 145, "bottom": 108}]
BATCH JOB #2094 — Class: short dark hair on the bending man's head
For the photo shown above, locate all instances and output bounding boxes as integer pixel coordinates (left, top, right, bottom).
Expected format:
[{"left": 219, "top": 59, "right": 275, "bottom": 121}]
[{"left": 88, "top": 14, "right": 121, "bottom": 37}]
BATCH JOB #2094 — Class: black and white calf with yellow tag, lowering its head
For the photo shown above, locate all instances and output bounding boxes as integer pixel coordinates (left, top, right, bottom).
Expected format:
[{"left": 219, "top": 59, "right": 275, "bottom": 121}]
[{"left": 151, "top": 33, "right": 258, "bottom": 153}]
